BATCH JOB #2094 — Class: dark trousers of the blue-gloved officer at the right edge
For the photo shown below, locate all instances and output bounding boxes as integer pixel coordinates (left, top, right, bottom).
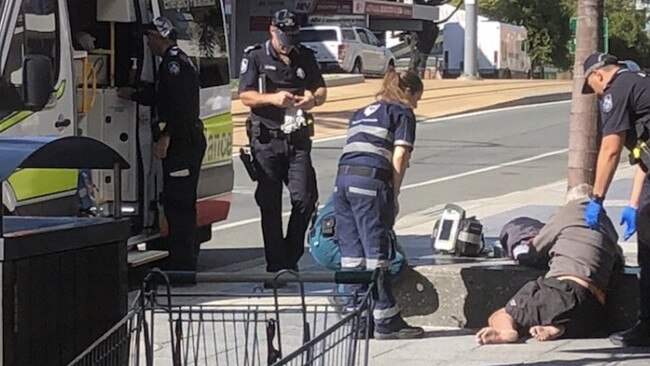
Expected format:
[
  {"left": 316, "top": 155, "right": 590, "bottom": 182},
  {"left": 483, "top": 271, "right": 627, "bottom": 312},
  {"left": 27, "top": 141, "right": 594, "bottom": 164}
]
[{"left": 636, "top": 174, "right": 650, "bottom": 324}]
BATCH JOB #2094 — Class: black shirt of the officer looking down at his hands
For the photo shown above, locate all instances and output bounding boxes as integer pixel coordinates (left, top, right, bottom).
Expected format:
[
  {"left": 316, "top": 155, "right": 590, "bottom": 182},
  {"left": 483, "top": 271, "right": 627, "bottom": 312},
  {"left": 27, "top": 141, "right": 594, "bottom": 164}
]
[{"left": 239, "top": 41, "right": 325, "bottom": 129}]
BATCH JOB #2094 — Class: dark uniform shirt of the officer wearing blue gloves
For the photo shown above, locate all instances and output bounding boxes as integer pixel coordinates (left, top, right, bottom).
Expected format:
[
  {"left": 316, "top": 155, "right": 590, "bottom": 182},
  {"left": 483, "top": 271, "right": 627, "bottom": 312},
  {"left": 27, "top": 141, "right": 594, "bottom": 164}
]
[{"left": 599, "top": 68, "right": 650, "bottom": 149}]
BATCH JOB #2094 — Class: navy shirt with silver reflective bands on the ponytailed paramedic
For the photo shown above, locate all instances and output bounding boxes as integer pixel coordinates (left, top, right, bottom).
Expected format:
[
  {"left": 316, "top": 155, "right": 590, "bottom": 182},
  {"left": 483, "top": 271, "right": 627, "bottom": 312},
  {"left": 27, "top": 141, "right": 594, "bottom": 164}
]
[{"left": 339, "top": 101, "right": 416, "bottom": 172}]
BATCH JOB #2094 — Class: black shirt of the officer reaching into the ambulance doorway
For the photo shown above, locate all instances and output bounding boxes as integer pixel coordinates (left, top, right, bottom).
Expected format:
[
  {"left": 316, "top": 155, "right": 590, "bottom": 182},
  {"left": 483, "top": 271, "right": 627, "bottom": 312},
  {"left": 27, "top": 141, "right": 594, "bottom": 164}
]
[{"left": 133, "top": 46, "right": 205, "bottom": 165}]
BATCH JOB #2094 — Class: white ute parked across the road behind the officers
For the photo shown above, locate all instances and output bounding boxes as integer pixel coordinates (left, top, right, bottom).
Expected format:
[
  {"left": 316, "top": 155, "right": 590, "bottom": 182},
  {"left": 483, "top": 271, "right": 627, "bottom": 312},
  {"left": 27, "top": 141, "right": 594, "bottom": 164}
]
[{"left": 300, "top": 25, "right": 395, "bottom": 74}]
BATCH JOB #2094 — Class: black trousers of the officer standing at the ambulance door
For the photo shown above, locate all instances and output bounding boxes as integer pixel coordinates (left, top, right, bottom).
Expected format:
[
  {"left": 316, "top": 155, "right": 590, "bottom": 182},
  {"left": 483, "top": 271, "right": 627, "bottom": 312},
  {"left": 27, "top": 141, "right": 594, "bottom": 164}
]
[{"left": 162, "top": 132, "right": 206, "bottom": 271}]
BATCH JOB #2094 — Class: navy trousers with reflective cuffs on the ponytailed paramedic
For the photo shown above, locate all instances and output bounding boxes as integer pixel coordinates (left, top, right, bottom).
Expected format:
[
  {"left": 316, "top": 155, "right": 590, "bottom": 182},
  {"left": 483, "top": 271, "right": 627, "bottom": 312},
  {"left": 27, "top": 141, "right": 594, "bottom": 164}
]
[{"left": 334, "top": 175, "right": 401, "bottom": 333}]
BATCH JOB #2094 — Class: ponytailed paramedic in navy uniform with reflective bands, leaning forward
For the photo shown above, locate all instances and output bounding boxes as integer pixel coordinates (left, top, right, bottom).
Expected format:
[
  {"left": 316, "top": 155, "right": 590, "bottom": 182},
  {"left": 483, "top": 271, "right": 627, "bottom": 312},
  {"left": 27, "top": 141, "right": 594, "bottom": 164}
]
[{"left": 334, "top": 69, "right": 424, "bottom": 339}]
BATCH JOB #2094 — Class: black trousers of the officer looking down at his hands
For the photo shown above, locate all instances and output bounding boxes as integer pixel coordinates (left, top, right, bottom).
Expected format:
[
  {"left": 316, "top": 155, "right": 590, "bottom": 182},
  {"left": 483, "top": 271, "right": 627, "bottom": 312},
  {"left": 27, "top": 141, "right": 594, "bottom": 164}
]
[{"left": 250, "top": 129, "right": 318, "bottom": 272}]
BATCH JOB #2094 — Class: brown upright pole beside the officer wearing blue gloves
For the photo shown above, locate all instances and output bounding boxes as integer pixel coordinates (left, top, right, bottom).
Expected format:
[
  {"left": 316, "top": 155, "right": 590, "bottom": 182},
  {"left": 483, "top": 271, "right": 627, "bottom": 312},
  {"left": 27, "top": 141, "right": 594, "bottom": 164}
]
[{"left": 567, "top": 0, "right": 599, "bottom": 189}]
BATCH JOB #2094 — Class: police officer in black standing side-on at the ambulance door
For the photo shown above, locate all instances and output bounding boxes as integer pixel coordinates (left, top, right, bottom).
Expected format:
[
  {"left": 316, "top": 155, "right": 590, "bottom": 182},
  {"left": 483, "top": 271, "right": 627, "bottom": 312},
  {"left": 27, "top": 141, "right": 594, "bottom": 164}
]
[{"left": 118, "top": 17, "right": 206, "bottom": 271}]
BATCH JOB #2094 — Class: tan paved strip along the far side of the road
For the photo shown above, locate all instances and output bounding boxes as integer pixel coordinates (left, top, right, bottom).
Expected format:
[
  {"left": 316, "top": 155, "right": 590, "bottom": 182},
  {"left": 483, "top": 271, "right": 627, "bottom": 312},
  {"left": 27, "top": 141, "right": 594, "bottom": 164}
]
[{"left": 232, "top": 79, "right": 571, "bottom": 152}]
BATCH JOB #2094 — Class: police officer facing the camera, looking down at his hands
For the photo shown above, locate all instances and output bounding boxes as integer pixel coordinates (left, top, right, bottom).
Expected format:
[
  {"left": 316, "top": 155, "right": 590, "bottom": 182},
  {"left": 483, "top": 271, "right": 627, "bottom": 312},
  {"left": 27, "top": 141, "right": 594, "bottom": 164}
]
[{"left": 239, "top": 9, "right": 327, "bottom": 278}]
